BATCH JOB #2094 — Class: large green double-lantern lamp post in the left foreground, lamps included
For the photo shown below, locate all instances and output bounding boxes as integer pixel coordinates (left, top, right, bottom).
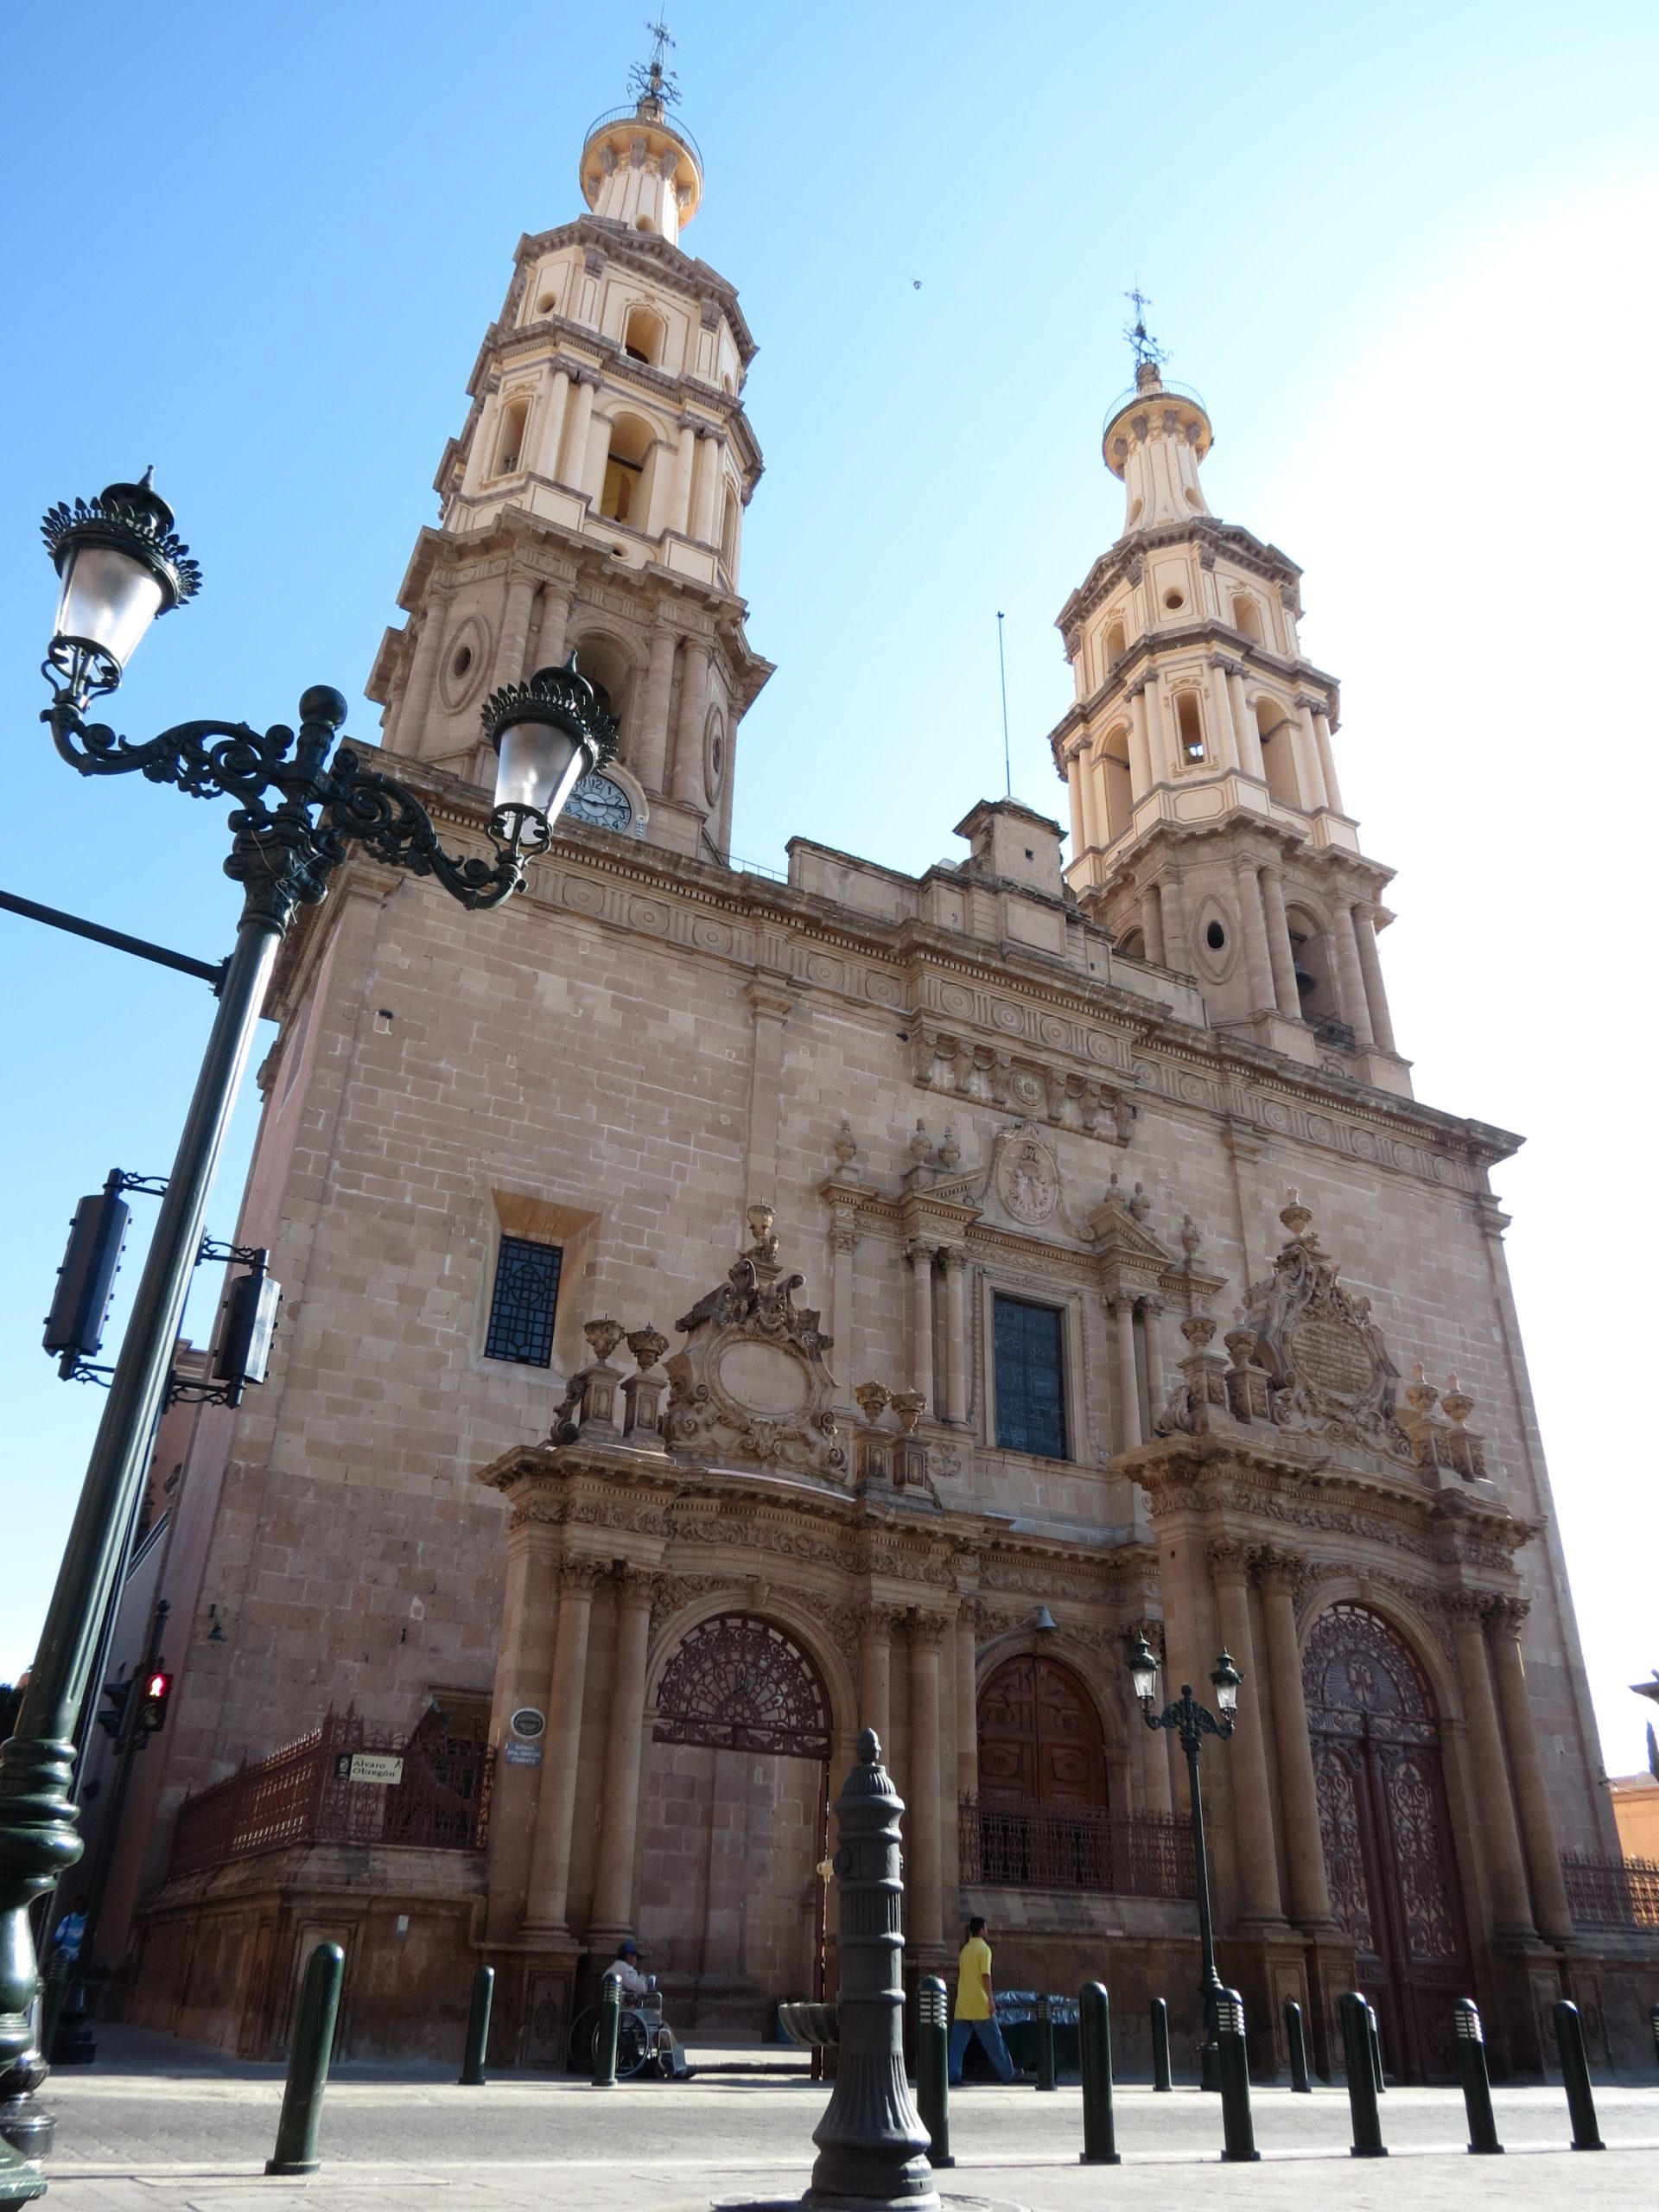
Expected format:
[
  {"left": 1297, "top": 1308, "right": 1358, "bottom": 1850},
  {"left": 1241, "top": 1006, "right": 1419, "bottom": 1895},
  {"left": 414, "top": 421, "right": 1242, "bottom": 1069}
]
[{"left": 0, "top": 471, "right": 615, "bottom": 2208}]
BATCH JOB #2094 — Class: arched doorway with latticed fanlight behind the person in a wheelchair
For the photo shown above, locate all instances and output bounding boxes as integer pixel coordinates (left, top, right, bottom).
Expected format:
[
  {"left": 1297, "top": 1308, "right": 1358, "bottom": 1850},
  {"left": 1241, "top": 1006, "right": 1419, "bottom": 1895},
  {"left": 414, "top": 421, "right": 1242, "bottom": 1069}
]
[{"left": 639, "top": 1612, "right": 830, "bottom": 2029}]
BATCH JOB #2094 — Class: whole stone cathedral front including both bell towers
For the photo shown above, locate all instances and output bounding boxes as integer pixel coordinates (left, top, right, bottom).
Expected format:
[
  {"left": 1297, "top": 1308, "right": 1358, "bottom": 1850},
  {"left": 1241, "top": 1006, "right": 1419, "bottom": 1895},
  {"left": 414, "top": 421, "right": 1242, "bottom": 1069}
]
[{"left": 99, "top": 55, "right": 1650, "bottom": 2079}]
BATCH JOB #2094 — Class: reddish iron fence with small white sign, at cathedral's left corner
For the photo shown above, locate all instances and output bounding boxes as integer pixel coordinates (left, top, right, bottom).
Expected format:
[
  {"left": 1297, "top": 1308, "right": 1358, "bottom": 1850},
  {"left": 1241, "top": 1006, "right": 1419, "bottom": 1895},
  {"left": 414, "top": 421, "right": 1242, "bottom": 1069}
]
[{"left": 168, "top": 1707, "right": 495, "bottom": 1873}]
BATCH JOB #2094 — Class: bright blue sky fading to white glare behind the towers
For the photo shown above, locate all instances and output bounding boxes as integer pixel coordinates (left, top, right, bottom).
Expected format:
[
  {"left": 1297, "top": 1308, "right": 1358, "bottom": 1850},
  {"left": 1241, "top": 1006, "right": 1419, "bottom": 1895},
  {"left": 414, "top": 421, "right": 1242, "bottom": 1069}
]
[{"left": 0, "top": 0, "right": 1659, "bottom": 1770}]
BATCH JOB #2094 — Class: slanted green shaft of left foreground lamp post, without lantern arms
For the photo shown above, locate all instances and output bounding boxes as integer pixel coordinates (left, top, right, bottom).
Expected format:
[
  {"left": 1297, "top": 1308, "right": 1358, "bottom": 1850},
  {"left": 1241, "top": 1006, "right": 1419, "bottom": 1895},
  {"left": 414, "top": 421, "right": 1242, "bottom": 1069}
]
[{"left": 0, "top": 882, "right": 292, "bottom": 2205}]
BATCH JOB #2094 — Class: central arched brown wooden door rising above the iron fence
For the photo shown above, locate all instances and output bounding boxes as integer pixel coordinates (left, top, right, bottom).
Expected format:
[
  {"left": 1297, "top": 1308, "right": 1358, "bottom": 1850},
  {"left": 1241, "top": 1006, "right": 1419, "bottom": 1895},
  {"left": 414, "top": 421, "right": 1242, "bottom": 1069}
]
[{"left": 978, "top": 1652, "right": 1106, "bottom": 1889}]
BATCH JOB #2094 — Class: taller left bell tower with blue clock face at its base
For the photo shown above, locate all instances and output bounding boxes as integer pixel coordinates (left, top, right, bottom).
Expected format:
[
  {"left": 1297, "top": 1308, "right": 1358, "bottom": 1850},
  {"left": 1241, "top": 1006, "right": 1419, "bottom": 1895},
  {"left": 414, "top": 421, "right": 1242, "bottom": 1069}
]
[{"left": 367, "top": 24, "right": 772, "bottom": 861}]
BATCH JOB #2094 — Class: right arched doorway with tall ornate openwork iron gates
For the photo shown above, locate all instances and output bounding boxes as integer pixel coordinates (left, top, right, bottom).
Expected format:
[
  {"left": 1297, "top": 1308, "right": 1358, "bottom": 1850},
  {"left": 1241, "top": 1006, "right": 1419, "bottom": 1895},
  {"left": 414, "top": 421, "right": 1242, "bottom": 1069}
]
[{"left": 1303, "top": 1606, "right": 1469, "bottom": 2082}]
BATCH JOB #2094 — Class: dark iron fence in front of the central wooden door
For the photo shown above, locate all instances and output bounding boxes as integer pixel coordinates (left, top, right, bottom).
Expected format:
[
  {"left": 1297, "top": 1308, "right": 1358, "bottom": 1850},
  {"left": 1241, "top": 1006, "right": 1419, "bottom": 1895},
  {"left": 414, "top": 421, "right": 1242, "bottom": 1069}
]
[{"left": 957, "top": 1796, "right": 1199, "bottom": 1897}]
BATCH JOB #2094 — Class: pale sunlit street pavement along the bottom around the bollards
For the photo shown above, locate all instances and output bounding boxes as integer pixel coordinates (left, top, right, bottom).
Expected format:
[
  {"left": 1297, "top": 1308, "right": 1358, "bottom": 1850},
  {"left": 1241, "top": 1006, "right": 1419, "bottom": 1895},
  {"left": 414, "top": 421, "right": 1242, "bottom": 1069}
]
[{"left": 22, "top": 2029, "right": 1659, "bottom": 2212}]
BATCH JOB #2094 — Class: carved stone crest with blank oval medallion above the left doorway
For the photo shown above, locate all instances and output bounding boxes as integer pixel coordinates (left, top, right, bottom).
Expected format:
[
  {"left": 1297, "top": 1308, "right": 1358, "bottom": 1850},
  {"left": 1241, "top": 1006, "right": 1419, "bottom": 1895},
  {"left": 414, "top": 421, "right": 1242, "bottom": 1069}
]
[{"left": 664, "top": 1205, "right": 847, "bottom": 1482}]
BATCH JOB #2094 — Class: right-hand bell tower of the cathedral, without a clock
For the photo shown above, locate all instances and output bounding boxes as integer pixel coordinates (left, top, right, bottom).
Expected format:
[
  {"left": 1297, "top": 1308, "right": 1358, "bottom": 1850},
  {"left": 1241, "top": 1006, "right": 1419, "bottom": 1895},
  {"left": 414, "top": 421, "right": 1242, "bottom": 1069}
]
[{"left": 1051, "top": 292, "right": 1411, "bottom": 1095}]
